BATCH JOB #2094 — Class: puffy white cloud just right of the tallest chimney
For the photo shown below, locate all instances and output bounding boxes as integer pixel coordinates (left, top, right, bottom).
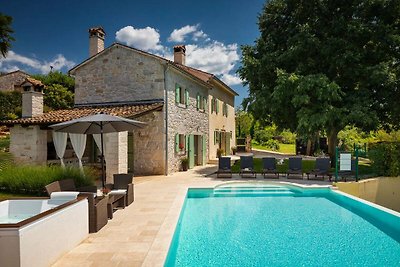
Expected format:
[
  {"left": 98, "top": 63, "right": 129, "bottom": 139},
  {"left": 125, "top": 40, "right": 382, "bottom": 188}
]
[{"left": 115, "top": 26, "right": 163, "bottom": 51}]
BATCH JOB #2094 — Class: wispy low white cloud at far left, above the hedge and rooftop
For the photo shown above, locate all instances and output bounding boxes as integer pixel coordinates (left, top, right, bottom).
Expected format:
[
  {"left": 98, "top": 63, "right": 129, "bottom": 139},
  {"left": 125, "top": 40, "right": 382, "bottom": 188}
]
[{"left": 0, "top": 50, "right": 75, "bottom": 73}]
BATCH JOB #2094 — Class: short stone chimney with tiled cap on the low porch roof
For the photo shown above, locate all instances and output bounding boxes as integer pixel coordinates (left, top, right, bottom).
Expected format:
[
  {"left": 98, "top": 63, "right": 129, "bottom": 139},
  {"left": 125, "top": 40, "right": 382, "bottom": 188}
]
[{"left": 20, "top": 78, "right": 44, "bottom": 118}]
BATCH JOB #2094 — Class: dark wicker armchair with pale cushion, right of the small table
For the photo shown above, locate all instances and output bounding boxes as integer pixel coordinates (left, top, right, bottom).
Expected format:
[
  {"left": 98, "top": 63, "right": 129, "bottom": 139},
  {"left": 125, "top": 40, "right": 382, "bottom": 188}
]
[{"left": 106, "top": 173, "right": 135, "bottom": 206}]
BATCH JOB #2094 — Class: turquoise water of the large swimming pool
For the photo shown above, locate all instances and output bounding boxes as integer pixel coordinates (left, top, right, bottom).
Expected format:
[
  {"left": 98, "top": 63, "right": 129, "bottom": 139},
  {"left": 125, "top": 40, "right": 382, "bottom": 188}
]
[{"left": 165, "top": 184, "right": 400, "bottom": 266}]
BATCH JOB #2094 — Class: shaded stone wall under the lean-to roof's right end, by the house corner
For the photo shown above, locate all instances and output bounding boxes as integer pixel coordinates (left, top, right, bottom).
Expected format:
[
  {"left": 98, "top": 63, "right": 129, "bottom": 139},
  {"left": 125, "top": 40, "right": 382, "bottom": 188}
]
[{"left": 133, "top": 111, "right": 165, "bottom": 175}]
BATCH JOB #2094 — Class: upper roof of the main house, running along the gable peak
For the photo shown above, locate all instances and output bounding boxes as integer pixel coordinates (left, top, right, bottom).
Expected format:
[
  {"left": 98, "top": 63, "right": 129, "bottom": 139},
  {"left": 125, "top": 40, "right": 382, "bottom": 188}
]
[{"left": 68, "top": 43, "right": 238, "bottom": 96}]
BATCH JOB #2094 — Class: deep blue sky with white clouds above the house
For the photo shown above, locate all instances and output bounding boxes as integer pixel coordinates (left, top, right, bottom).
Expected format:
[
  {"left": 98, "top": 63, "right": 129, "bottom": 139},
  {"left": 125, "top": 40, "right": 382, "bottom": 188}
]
[{"left": 0, "top": 0, "right": 264, "bottom": 105}]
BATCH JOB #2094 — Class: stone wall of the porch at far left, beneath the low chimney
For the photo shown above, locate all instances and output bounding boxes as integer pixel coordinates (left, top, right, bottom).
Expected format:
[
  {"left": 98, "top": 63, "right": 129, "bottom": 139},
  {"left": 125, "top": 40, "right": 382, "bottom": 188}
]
[{"left": 10, "top": 125, "right": 47, "bottom": 164}]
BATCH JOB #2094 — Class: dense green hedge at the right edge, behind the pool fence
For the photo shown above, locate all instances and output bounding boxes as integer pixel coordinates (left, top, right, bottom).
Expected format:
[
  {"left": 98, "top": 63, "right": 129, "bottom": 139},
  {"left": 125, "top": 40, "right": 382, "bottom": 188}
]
[{"left": 369, "top": 142, "right": 400, "bottom": 176}]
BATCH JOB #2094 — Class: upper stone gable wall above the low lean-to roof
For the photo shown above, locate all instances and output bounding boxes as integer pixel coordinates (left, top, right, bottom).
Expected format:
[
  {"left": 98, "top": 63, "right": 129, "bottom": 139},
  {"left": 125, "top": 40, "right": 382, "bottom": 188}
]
[{"left": 71, "top": 44, "right": 164, "bottom": 104}]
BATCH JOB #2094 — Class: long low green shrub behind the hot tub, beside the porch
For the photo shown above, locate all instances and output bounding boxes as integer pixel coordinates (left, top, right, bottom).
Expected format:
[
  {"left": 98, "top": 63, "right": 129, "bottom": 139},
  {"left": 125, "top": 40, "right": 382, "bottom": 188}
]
[{"left": 0, "top": 165, "right": 96, "bottom": 195}]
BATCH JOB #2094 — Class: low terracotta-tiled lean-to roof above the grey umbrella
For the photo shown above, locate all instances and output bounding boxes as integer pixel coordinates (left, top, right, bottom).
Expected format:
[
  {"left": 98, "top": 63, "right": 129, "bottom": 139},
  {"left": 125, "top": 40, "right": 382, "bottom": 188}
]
[{"left": 0, "top": 102, "right": 163, "bottom": 126}]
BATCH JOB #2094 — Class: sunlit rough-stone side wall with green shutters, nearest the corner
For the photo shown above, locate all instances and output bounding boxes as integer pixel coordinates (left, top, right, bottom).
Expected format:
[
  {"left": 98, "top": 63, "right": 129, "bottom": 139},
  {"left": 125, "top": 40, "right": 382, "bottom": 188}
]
[{"left": 166, "top": 68, "right": 209, "bottom": 173}]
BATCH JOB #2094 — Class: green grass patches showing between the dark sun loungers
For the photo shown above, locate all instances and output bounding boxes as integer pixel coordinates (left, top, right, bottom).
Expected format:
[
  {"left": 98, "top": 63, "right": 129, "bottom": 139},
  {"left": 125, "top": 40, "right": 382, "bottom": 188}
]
[{"left": 232, "top": 158, "right": 374, "bottom": 178}]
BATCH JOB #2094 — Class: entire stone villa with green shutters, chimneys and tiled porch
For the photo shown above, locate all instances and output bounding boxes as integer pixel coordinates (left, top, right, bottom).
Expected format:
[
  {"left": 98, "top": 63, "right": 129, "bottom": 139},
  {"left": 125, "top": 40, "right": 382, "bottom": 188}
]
[{"left": 5, "top": 28, "right": 237, "bottom": 182}]
